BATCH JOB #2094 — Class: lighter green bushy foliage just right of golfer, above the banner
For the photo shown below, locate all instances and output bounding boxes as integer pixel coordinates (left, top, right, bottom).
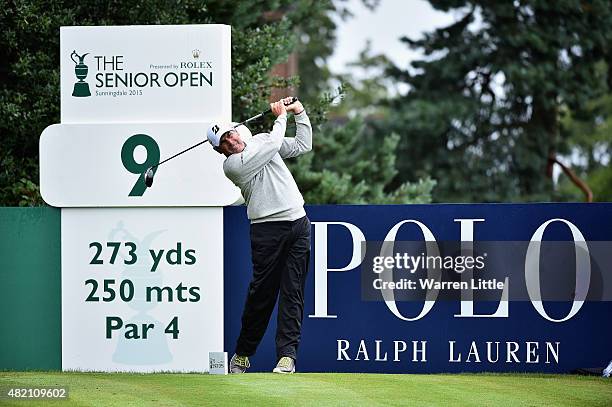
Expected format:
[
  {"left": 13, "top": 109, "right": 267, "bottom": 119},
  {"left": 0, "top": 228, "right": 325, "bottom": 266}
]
[{"left": 289, "top": 89, "right": 436, "bottom": 204}]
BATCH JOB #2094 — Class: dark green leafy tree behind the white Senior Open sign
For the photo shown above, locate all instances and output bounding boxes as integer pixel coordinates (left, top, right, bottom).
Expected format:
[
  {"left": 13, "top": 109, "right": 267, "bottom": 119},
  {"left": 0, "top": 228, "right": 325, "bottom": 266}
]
[{"left": 0, "top": 0, "right": 295, "bottom": 205}]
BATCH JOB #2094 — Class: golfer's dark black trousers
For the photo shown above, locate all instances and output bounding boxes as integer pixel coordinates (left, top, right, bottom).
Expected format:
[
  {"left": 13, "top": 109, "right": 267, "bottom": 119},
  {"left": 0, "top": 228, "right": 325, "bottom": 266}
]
[{"left": 236, "top": 216, "right": 310, "bottom": 360}]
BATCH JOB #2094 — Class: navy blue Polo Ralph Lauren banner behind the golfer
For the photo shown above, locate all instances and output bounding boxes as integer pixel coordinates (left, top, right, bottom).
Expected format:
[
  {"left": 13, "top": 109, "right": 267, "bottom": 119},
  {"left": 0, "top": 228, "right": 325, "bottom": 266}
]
[{"left": 224, "top": 203, "right": 612, "bottom": 373}]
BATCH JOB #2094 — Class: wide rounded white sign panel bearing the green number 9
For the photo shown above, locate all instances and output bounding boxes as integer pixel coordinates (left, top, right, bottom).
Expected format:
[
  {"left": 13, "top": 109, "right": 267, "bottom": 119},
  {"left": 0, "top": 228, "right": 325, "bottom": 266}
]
[{"left": 40, "top": 123, "right": 241, "bottom": 207}]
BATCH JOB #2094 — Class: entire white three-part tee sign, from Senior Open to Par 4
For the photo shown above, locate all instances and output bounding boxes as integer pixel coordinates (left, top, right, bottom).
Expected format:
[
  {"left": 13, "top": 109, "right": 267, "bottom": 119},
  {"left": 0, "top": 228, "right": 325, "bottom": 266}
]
[{"left": 40, "top": 25, "right": 232, "bottom": 372}]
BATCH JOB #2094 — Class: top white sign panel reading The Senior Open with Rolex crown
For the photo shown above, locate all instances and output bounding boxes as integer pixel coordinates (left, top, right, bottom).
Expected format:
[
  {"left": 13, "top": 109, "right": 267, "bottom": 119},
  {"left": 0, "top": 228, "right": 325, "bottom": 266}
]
[{"left": 60, "top": 24, "right": 231, "bottom": 123}]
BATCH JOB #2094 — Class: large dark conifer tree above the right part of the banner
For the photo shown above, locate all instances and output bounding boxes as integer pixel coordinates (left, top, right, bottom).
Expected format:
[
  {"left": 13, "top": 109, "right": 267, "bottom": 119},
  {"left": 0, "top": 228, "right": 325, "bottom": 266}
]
[{"left": 379, "top": 0, "right": 612, "bottom": 202}]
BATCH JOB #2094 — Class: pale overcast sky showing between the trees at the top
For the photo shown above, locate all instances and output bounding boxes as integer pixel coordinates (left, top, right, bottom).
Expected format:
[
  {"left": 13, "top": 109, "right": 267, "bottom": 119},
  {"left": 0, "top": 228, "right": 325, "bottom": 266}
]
[{"left": 328, "top": 0, "right": 454, "bottom": 73}]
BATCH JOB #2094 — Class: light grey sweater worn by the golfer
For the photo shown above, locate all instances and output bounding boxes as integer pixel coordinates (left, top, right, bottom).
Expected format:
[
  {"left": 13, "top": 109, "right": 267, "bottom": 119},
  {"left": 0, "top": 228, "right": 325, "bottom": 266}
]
[{"left": 223, "top": 112, "right": 312, "bottom": 223}]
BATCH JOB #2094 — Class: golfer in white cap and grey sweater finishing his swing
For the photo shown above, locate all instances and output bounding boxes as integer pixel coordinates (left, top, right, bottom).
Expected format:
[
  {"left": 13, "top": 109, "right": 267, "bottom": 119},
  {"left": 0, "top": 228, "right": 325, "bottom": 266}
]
[{"left": 208, "top": 98, "right": 312, "bottom": 373}]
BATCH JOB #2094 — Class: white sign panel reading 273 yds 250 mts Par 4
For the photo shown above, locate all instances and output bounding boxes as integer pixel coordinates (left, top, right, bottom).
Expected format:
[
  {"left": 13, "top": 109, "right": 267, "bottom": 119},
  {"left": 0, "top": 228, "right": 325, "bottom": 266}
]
[{"left": 62, "top": 208, "right": 223, "bottom": 372}]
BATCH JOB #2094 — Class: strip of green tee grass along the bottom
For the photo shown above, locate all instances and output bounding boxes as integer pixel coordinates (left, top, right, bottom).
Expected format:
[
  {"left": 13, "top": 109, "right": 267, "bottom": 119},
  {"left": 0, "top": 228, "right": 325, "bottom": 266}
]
[{"left": 0, "top": 372, "right": 612, "bottom": 407}]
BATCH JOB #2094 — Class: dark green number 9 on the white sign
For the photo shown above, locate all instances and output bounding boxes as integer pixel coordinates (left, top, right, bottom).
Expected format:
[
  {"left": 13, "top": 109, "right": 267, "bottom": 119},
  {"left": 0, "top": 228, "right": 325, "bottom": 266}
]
[{"left": 121, "top": 134, "right": 160, "bottom": 196}]
